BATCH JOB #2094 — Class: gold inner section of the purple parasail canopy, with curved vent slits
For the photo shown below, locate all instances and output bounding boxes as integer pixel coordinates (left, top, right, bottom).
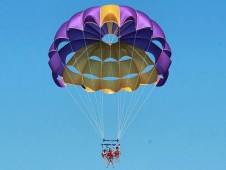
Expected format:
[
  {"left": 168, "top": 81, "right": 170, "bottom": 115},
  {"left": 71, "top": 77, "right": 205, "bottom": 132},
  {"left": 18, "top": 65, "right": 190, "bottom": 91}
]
[{"left": 63, "top": 42, "right": 158, "bottom": 94}]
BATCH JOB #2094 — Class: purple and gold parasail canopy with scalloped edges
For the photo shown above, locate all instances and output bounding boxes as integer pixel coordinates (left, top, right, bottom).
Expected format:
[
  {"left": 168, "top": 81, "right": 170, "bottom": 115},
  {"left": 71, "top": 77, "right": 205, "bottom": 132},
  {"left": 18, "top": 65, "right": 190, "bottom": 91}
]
[{"left": 49, "top": 5, "right": 171, "bottom": 166}]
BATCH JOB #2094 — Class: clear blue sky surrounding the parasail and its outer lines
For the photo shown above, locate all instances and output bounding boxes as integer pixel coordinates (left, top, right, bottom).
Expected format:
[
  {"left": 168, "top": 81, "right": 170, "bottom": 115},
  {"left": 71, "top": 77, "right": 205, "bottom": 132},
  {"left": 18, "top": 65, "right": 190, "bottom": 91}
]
[{"left": 0, "top": 0, "right": 226, "bottom": 170}]
